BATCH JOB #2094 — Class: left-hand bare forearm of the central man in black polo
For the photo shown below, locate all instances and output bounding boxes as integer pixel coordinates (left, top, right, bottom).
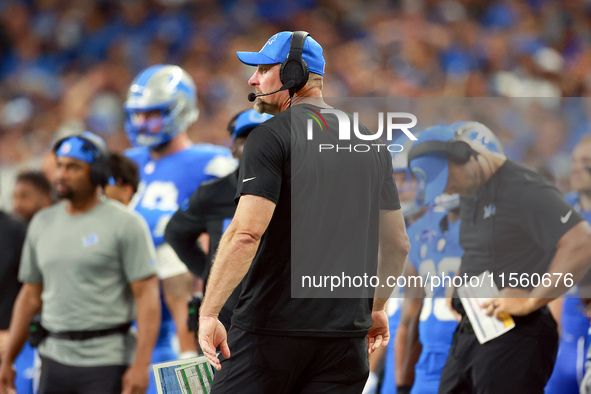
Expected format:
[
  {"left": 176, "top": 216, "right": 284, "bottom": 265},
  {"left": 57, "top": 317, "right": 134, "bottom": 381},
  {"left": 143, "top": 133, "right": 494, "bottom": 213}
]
[{"left": 199, "top": 228, "right": 260, "bottom": 317}]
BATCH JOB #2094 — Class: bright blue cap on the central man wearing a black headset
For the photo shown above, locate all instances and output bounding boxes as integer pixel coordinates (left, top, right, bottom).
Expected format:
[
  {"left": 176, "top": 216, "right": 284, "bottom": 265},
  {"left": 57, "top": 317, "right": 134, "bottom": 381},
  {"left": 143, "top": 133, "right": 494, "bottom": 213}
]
[{"left": 236, "top": 31, "right": 326, "bottom": 75}]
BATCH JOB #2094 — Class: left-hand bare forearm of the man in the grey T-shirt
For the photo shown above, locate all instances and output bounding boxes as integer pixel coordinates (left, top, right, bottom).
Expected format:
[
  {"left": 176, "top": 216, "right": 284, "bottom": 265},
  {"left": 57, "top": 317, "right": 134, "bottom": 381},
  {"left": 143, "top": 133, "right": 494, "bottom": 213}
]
[{"left": 2, "top": 284, "right": 41, "bottom": 364}]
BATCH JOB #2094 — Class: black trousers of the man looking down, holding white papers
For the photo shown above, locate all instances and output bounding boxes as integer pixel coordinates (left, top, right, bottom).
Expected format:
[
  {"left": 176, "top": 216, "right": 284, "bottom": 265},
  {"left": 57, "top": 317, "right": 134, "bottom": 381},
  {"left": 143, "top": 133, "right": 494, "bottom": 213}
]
[{"left": 439, "top": 308, "right": 558, "bottom": 394}]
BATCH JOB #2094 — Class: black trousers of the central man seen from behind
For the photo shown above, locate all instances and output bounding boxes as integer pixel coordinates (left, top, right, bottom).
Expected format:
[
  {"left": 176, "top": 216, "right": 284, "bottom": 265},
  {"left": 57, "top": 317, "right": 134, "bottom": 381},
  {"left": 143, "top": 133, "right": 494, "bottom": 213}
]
[{"left": 212, "top": 327, "right": 369, "bottom": 394}]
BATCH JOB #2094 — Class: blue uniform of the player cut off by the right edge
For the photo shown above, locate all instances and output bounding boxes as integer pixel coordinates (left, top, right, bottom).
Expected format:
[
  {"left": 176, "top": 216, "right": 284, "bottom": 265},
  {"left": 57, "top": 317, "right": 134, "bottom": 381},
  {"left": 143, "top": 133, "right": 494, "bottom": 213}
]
[{"left": 545, "top": 192, "right": 591, "bottom": 394}]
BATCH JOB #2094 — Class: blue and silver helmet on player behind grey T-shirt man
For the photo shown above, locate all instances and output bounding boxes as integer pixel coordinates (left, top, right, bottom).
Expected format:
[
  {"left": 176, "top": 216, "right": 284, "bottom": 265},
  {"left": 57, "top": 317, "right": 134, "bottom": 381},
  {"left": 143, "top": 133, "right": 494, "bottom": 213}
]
[{"left": 124, "top": 65, "right": 199, "bottom": 148}]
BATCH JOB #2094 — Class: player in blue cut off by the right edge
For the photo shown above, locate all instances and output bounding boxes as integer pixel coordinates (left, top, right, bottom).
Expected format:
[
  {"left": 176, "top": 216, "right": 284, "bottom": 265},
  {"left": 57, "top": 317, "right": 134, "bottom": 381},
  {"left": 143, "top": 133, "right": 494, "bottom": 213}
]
[{"left": 544, "top": 136, "right": 591, "bottom": 394}]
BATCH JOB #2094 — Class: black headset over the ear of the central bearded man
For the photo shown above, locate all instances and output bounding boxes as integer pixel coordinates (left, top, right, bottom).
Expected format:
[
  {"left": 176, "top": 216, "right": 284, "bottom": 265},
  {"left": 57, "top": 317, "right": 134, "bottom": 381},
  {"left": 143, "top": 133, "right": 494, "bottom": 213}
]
[{"left": 279, "top": 30, "right": 310, "bottom": 97}]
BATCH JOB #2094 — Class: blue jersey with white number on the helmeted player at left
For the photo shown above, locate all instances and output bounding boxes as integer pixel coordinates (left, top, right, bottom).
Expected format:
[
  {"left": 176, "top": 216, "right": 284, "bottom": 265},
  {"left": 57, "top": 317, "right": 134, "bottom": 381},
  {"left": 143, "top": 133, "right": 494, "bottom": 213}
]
[{"left": 125, "top": 144, "right": 236, "bottom": 247}]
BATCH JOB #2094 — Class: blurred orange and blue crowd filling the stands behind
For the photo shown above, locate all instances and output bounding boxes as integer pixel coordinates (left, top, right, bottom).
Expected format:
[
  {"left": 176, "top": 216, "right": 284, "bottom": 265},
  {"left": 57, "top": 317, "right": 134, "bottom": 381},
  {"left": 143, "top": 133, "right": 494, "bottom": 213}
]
[{"left": 0, "top": 0, "right": 591, "bottom": 207}]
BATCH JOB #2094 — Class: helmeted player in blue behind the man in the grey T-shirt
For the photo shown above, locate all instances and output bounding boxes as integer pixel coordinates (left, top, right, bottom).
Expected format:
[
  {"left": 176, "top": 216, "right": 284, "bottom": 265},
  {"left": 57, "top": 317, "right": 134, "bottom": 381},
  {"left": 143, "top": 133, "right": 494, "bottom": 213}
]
[{"left": 125, "top": 65, "right": 236, "bottom": 391}]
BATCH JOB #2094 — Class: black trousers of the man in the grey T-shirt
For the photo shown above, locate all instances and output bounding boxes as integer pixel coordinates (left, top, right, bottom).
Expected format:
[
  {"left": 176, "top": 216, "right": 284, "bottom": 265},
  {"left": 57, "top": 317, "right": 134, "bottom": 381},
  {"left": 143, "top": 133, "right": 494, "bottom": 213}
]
[{"left": 39, "top": 356, "right": 128, "bottom": 394}]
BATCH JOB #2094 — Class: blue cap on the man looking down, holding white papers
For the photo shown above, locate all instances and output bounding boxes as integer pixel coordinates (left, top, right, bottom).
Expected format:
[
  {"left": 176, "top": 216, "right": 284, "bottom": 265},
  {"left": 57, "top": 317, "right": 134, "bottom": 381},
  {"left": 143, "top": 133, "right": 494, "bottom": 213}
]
[{"left": 409, "top": 125, "right": 455, "bottom": 204}]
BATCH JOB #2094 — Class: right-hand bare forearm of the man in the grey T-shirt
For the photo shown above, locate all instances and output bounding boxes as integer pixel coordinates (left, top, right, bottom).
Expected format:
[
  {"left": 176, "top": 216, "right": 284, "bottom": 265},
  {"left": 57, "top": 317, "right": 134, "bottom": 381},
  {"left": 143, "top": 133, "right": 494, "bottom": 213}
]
[{"left": 134, "top": 278, "right": 161, "bottom": 366}]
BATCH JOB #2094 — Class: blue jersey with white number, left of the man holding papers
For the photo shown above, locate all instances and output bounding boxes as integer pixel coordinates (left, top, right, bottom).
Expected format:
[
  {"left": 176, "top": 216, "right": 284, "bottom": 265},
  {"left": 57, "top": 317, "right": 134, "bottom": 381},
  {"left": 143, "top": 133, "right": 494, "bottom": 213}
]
[{"left": 409, "top": 211, "right": 463, "bottom": 393}]
